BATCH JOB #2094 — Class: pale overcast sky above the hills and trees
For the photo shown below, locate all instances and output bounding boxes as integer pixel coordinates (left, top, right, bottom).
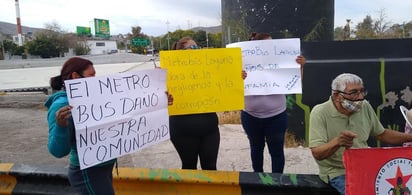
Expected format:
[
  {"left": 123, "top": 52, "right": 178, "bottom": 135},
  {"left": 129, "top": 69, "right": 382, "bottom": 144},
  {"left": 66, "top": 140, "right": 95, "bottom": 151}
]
[{"left": 0, "top": 0, "right": 412, "bottom": 36}]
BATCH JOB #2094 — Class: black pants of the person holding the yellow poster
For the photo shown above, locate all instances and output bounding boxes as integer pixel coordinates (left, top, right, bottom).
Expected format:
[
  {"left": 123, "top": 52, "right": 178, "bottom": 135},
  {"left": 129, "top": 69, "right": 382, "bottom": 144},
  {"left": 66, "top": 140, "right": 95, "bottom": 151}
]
[{"left": 169, "top": 113, "right": 220, "bottom": 170}]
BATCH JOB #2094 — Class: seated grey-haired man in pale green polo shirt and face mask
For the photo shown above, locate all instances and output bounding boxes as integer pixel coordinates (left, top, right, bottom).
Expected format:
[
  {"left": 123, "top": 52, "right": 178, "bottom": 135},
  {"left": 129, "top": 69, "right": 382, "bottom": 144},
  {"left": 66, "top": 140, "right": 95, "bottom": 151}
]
[{"left": 309, "top": 73, "right": 412, "bottom": 194}]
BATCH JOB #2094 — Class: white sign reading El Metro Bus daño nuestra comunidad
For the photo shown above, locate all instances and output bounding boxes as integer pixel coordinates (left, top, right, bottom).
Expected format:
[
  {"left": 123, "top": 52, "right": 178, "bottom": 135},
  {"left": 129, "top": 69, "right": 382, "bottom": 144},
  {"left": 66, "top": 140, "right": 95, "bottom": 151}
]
[{"left": 65, "top": 69, "right": 170, "bottom": 169}]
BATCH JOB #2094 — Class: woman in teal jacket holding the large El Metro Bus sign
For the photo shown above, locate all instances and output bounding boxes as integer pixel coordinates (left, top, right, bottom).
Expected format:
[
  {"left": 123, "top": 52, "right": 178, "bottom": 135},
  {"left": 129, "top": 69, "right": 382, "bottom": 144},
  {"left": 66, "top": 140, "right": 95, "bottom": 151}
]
[{"left": 45, "top": 57, "right": 116, "bottom": 195}]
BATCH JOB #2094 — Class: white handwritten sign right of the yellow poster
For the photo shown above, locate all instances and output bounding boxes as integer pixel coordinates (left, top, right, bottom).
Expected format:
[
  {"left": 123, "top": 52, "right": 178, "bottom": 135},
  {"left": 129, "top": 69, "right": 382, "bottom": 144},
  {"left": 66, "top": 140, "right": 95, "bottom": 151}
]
[{"left": 226, "top": 38, "right": 302, "bottom": 95}]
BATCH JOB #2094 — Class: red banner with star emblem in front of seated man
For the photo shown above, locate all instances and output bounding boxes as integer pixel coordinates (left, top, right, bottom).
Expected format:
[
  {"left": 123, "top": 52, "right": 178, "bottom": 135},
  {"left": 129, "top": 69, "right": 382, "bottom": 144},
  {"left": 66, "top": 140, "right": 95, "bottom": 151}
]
[{"left": 343, "top": 147, "right": 412, "bottom": 195}]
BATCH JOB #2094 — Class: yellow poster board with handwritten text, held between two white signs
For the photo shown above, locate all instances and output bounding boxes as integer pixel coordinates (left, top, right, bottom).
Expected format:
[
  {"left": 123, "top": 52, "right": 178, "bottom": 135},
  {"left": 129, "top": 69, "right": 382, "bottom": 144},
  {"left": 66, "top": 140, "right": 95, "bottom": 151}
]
[{"left": 160, "top": 48, "right": 244, "bottom": 115}]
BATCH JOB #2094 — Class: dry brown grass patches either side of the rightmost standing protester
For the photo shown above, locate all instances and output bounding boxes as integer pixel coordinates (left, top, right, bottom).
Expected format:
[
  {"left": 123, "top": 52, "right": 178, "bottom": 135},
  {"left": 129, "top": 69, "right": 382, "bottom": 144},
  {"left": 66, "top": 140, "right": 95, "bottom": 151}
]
[{"left": 217, "top": 111, "right": 303, "bottom": 148}]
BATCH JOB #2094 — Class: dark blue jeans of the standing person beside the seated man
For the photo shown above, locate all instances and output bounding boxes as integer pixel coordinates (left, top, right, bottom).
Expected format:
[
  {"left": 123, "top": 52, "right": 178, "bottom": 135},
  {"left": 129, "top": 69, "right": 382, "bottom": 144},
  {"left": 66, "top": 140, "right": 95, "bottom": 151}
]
[{"left": 241, "top": 111, "right": 288, "bottom": 173}]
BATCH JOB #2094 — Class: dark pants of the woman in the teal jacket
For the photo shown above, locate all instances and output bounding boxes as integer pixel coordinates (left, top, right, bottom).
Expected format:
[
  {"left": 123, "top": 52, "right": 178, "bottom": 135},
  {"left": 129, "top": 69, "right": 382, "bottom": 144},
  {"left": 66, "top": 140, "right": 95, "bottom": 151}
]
[{"left": 69, "top": 163, "right": 114, "bottom": 195}]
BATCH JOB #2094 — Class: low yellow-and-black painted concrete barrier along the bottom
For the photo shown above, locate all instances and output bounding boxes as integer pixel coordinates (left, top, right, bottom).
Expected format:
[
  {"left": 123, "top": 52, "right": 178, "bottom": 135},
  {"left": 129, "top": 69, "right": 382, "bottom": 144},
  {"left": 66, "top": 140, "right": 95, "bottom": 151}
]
[{"left": 0, "top": 163, "right": 338, "bottom": 195}]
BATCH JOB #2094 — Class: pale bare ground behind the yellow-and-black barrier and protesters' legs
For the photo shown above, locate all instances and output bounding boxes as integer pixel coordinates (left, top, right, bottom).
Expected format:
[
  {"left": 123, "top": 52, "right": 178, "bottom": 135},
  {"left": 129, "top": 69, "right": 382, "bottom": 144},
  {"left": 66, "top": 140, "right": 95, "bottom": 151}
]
[{"left": 0, "top": 94, "right": 319, "bottom": 174}]
